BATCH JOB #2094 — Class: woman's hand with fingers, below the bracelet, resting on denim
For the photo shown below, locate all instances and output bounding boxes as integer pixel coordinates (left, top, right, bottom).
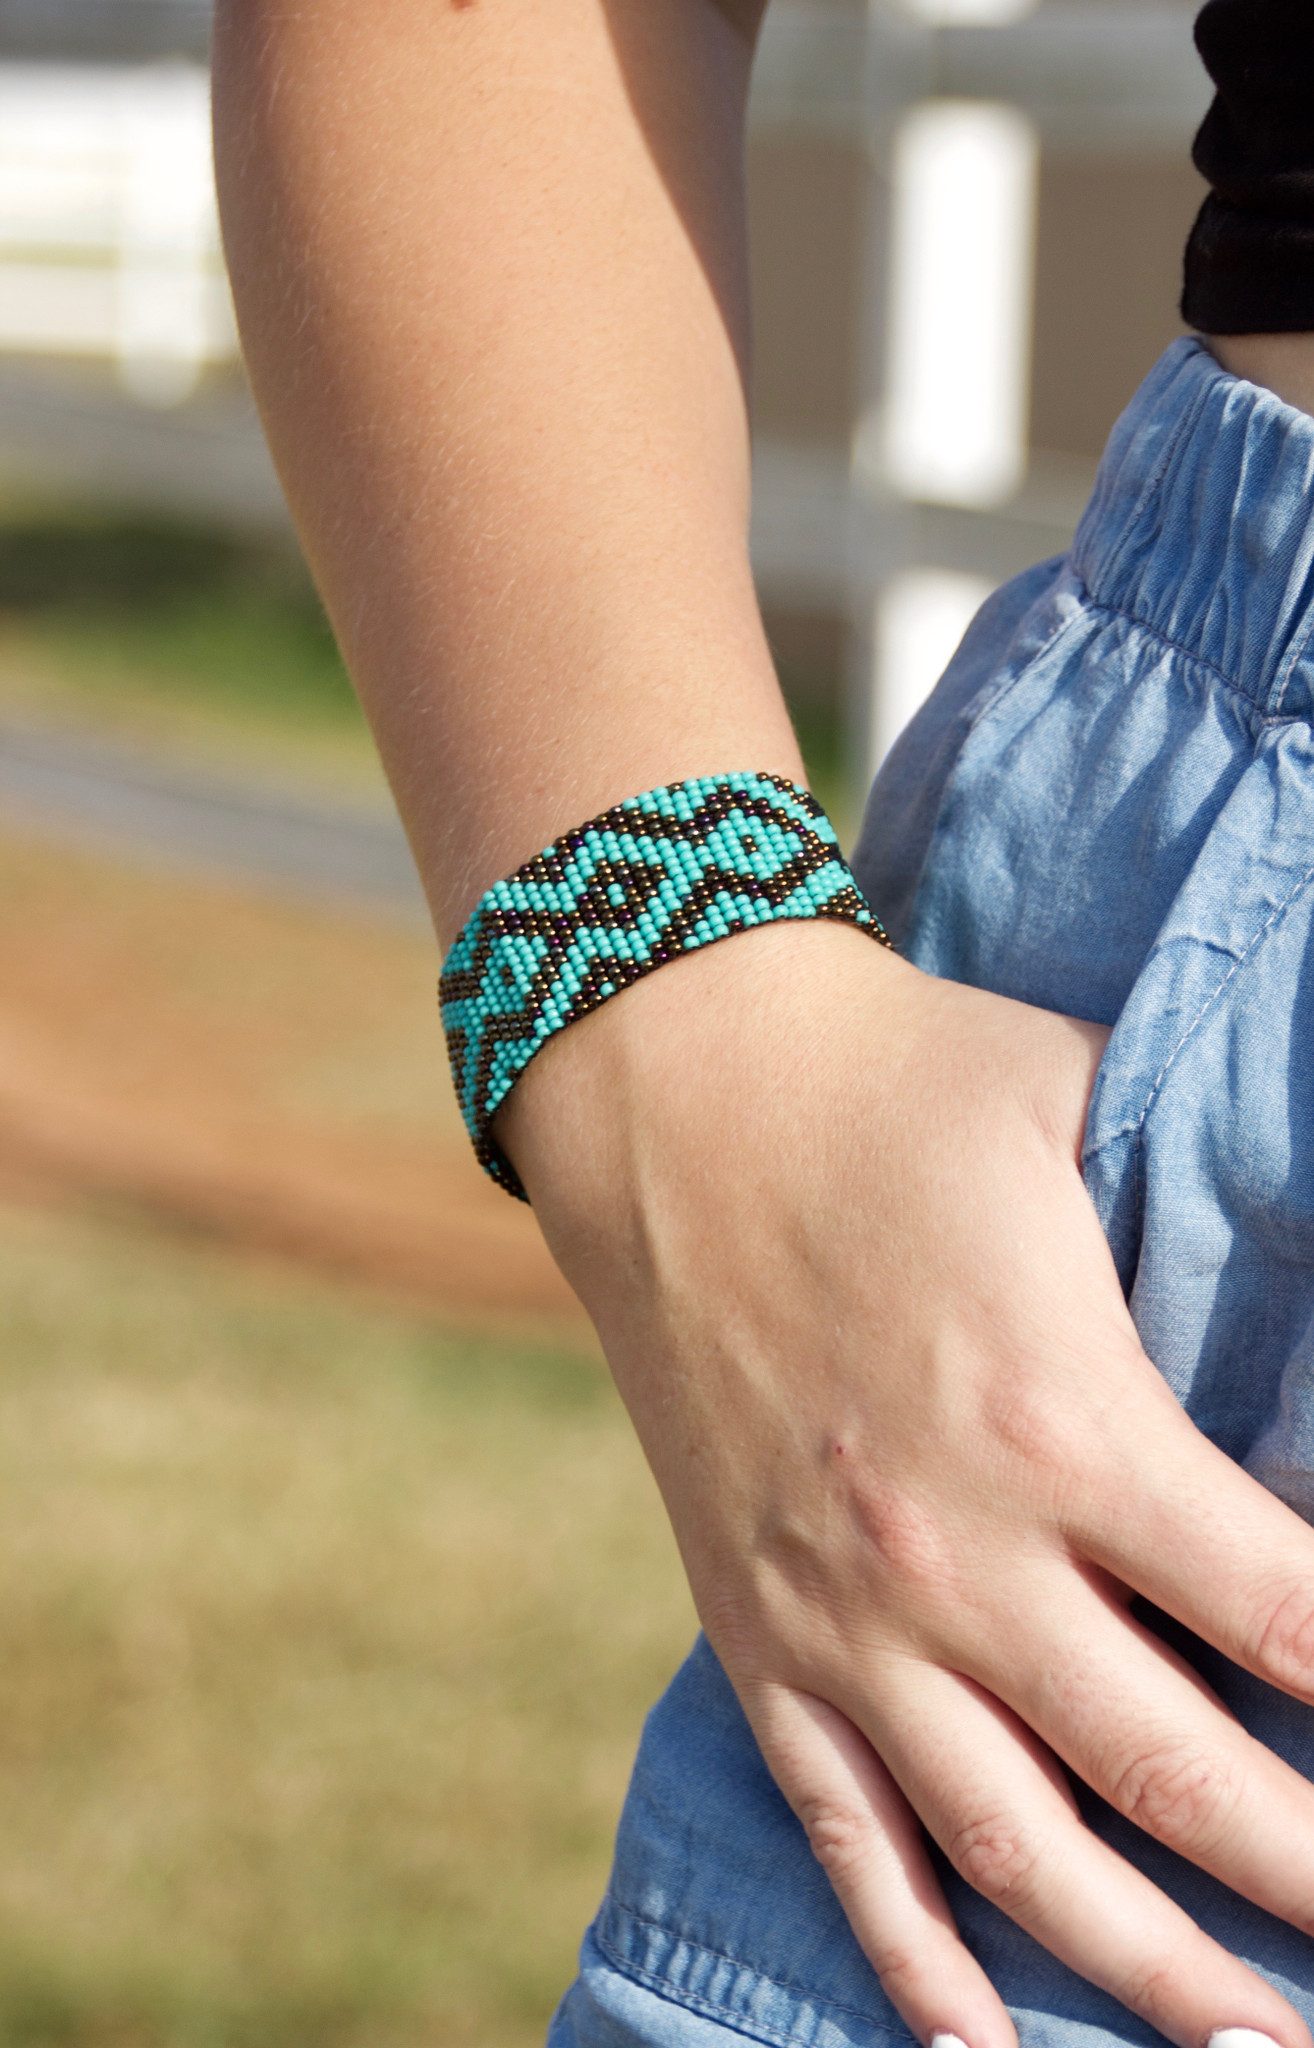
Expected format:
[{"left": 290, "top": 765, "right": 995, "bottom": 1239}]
[{"left": 499, "top": 924, "right": 1314, "bottom": 2048}]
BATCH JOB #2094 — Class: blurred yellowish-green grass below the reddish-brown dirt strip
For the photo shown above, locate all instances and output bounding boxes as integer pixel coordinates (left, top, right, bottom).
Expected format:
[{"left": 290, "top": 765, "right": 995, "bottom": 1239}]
[{"left": 0, "top": 1214, "right": 692, "bottom": 2048}]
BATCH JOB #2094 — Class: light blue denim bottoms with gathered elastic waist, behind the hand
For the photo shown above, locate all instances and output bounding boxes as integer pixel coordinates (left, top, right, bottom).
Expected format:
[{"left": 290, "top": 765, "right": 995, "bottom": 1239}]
[{"left": 549, "top": 340, "right": 1314, "bottom": 2048}]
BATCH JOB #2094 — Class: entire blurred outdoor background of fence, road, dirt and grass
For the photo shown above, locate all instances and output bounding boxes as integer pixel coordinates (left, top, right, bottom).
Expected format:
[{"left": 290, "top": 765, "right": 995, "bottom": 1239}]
[{"left": 0, "top": 0, "right": 1208, "bottom": 2048}]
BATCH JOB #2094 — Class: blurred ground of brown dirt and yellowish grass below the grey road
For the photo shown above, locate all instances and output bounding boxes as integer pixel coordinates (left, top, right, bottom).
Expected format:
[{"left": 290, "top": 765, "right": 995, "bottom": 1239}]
[{"left": 0, "top": 811, "right": 692, "bottom": 2048}]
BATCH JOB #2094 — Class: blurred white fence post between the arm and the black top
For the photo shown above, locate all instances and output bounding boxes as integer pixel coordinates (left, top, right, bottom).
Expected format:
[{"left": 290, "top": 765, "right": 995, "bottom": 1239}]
[{"left": 849, "top": 0, "right": 1040, "bottom": 788}]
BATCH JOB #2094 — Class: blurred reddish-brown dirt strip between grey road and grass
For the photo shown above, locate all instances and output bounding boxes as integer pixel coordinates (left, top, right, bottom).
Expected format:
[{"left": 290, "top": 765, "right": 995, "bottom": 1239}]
[{"left": 0, "top": 834, "right": 583, "bottom": 1341}]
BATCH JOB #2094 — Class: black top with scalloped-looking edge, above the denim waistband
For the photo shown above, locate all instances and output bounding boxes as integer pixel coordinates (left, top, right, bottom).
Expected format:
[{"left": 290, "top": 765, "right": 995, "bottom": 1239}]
[{"left": 1181, "top": 0, "right": 1314, "bottom": 334}]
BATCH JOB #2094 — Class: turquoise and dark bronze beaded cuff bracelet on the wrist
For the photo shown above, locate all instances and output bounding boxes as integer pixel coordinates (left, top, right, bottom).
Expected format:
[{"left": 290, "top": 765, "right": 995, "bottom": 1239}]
[{"left": 438, "top": 774, "right": 890, "bottom": 1202}]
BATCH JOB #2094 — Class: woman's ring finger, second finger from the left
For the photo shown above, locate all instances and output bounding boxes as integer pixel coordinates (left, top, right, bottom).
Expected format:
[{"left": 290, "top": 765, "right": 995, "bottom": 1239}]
[{"left": 855, "top": 1667, "right": 1310, "bottom": 2048}]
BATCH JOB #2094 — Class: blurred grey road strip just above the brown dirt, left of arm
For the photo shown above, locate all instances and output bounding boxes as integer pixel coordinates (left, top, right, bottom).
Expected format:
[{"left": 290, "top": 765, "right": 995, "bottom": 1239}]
[{"left": 0, "top": 723, "right": 424, "bottom": 920}]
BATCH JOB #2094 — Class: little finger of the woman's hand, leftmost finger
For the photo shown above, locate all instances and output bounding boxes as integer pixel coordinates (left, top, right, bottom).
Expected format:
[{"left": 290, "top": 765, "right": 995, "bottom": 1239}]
[{"left": 741, "top": 1686, "right": 1017, "bottom": 2048}]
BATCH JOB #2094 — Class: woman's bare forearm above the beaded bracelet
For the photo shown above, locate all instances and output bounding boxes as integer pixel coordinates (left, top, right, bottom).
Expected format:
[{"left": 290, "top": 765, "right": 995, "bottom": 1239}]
[{"left": 215, "top": 0, "right": 800, "bottom": 938}]
